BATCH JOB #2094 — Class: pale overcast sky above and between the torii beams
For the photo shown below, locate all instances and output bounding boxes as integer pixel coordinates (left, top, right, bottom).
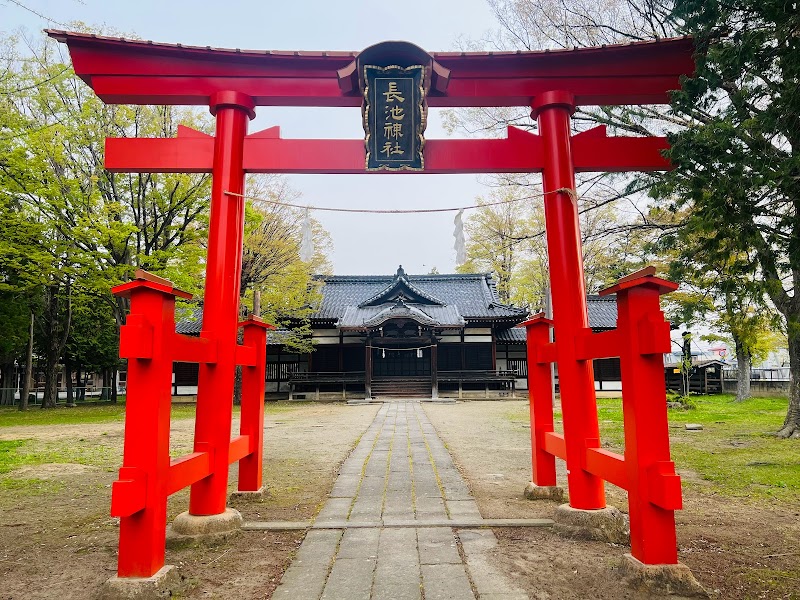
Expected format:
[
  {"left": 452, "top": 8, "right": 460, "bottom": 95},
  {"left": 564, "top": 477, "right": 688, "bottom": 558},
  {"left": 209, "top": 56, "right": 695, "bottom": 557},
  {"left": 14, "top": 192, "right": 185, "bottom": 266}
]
[{"left": 0, "top": 0, "right": 504, "bottom": 275}]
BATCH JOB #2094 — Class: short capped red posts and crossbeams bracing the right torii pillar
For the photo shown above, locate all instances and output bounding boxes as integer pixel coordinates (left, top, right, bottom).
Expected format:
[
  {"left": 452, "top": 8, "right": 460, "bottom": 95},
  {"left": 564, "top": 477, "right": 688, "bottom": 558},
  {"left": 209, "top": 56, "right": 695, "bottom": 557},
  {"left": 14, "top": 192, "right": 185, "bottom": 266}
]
[{"left": 525, "top": 267, "right": 682, "bottom": 565}]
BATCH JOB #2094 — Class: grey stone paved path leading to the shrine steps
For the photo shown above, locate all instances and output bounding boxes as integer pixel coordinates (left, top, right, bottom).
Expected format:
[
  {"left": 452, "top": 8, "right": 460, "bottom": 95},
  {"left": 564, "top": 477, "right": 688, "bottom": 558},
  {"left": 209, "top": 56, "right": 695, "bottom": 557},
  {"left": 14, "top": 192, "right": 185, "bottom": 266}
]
[{"left": 272, "top": 401, "right": 528, "bottom": 600}]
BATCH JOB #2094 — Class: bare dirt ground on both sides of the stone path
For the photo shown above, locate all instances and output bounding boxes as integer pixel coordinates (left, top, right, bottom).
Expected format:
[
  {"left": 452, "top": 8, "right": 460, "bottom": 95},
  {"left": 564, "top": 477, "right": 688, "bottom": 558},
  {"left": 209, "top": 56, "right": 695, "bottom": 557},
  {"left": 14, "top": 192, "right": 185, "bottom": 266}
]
[{"left": 0, "top": 401, "right": 800, "bottom": 600}]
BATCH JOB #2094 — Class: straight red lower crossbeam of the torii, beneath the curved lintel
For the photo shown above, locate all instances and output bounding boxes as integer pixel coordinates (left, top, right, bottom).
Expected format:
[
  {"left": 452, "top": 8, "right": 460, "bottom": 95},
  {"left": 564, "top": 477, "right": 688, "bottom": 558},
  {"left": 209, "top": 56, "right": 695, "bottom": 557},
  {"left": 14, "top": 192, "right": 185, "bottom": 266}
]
[{"left": 106, "top": 127, "right": 669, "bottom": 174}]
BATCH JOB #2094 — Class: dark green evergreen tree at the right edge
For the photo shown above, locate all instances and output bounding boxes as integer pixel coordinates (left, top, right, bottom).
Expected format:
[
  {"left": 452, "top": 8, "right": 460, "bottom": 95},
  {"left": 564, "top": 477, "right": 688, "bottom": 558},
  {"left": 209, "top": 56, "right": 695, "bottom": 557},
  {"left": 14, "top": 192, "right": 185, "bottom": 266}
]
[{"left": 660, "top": 0, "right": 800, "bottom": 438}]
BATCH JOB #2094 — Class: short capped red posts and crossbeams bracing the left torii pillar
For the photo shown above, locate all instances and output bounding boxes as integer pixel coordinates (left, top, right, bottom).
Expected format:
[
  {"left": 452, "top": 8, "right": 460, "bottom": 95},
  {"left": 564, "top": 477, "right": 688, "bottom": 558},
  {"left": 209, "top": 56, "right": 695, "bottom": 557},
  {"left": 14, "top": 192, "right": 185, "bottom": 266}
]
[{"left": 111, "top": 271, "right": 272, "bottom": 583}]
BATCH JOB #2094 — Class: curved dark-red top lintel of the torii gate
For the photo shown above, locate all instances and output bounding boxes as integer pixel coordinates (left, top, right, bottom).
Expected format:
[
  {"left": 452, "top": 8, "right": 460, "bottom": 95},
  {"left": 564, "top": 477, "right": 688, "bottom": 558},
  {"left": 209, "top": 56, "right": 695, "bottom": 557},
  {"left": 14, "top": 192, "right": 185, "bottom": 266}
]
[{"left": 49, "top": 31, "right": 694, "bottom": 107}]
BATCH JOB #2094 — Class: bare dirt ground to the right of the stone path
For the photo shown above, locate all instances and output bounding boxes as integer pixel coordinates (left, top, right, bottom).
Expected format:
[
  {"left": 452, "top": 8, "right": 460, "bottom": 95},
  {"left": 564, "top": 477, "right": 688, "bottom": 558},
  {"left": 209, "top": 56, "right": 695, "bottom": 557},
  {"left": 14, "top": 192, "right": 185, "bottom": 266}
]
[{"left": 425, "top": 402, "right": 800, "bottom": 600}]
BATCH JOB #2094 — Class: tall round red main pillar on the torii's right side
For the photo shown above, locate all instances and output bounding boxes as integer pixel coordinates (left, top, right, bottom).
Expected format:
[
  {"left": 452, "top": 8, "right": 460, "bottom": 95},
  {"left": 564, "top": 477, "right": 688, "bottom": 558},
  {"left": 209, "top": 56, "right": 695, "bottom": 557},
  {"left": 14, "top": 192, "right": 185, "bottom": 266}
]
[{"left": 532, "top": 91, "right": 606, "bottom": 510}]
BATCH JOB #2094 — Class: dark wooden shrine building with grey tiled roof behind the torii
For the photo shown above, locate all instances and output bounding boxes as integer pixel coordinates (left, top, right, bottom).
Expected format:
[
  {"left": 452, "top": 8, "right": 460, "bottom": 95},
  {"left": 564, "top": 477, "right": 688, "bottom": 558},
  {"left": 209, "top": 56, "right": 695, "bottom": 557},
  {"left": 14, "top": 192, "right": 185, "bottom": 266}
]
[{"left": 250, "top": 267, "right": 620, "bottom": 400}]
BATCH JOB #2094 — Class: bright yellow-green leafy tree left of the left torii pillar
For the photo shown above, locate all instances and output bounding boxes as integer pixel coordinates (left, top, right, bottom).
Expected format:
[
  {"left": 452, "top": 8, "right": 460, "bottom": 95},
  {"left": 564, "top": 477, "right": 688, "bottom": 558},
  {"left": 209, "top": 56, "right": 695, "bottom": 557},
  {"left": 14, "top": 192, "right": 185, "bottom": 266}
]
[{"left": 0, "top": 30, "right": 210, "bottom": 405}]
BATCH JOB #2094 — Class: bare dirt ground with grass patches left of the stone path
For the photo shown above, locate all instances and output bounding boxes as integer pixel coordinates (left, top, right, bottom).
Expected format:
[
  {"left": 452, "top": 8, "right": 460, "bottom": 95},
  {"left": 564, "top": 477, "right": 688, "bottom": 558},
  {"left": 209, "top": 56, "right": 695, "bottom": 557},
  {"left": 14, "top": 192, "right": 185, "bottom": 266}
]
[{"left": 0, "top": 404, "right": 377, "bottom": 600}]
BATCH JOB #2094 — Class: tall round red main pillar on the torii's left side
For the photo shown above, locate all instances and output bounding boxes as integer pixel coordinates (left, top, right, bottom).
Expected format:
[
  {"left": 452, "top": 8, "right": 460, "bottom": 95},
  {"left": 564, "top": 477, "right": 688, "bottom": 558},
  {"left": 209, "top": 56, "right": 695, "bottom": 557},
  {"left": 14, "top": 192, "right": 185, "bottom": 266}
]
[{"left": 189, "top": 92, "right": 253, "bottom": 516}]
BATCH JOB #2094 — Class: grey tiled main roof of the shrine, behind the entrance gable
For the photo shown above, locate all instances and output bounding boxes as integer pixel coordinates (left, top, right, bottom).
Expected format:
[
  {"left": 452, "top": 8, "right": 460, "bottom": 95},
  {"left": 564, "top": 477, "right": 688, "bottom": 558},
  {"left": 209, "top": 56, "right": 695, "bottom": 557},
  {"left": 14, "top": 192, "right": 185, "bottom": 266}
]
[{"left": 312, "top": 273, "right": 527, "bottom": 321}]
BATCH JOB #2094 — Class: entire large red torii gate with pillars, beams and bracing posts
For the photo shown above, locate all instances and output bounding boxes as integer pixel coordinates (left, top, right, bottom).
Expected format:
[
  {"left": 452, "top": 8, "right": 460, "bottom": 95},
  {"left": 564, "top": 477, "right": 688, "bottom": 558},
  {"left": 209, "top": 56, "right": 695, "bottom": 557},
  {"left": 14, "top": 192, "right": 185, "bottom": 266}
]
[{"left": 48, "top": 30, "right": 694, "bottom": 577}]
